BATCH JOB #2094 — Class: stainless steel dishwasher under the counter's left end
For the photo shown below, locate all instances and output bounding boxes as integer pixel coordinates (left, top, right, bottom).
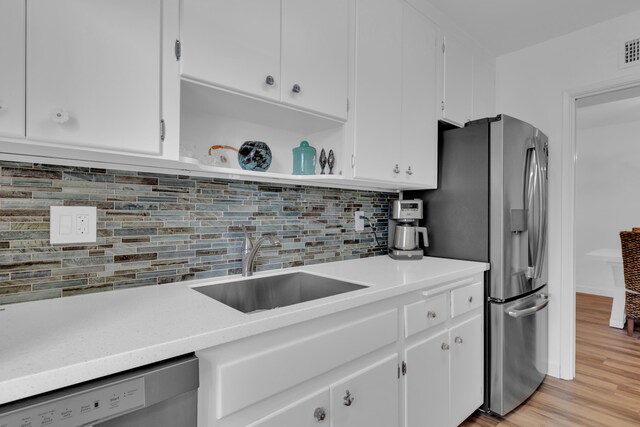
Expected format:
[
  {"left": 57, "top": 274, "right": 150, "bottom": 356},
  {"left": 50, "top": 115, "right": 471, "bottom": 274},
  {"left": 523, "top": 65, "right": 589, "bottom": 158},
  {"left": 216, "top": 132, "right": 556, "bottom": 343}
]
[{"left": 0, "top": 354, "right": 199, "bottom": 427}]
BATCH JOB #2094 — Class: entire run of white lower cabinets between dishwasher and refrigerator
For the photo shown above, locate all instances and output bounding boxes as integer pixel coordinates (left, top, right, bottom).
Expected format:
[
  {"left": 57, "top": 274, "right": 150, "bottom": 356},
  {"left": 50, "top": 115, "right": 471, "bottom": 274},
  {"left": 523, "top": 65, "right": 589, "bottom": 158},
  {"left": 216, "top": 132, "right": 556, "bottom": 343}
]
[{"left": 197, "top": 274, "right": 484, "bottom": 427}]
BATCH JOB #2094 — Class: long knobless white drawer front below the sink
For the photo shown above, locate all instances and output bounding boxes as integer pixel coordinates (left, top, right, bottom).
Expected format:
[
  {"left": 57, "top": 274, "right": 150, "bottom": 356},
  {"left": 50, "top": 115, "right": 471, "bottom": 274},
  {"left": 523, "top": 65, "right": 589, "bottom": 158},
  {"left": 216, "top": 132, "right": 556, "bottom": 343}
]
[{"left": 216, "top": 309, "right": 398, "bottom": 418}]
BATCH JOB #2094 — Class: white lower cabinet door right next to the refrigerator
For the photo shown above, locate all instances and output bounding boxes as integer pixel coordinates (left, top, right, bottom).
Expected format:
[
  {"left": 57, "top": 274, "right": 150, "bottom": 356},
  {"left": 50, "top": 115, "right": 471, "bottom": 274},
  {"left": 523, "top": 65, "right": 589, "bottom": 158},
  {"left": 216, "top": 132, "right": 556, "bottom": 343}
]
[{"left": 450, "top": 315, "right": 484, "bottom": 425}]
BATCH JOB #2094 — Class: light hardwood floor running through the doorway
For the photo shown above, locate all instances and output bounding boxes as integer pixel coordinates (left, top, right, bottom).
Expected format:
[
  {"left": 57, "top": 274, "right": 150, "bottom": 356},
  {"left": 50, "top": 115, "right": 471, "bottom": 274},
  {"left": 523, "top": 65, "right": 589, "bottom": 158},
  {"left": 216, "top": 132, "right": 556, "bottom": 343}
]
[{"left": 462, "top": 294, "right": 640, "bottom": 427}]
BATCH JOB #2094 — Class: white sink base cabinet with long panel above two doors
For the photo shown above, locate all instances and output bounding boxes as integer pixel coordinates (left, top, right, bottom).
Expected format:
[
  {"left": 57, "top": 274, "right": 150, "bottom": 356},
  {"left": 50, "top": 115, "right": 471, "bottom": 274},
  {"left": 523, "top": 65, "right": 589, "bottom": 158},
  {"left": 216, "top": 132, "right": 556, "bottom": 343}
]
[{"left": 198, "top": 304, "right": 399, "bottom": 427}]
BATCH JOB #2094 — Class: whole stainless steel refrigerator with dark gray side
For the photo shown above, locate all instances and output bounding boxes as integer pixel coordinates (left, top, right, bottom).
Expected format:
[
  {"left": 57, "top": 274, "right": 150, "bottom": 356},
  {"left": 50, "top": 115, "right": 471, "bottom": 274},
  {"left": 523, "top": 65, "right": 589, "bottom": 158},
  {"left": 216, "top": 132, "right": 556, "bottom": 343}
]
[{"left": 404, "top": 114, "right": 549, "bottom": 415}]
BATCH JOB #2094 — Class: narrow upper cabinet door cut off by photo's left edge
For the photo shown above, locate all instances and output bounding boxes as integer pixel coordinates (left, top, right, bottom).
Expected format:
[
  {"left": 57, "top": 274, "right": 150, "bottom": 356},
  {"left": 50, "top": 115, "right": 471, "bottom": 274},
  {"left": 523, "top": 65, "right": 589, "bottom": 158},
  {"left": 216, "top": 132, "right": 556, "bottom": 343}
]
[{"left": 0, "top": 0, "right": 26, "bottom": 137}]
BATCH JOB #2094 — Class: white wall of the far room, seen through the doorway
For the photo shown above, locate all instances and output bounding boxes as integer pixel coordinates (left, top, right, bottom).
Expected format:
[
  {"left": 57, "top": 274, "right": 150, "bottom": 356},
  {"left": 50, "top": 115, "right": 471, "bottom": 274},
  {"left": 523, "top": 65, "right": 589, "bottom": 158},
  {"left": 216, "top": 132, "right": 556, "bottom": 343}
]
[{"left": 575, "top": 115, "right": 640, "bottom": 296}]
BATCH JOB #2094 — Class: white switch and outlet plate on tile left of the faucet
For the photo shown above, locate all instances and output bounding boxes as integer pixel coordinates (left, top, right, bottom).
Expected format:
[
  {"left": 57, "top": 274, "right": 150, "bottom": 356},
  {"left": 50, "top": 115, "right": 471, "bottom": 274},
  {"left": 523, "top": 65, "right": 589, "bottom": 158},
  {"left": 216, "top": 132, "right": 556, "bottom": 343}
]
[{"left": 49, "top": 206, "right": 96, "bottom": 245}]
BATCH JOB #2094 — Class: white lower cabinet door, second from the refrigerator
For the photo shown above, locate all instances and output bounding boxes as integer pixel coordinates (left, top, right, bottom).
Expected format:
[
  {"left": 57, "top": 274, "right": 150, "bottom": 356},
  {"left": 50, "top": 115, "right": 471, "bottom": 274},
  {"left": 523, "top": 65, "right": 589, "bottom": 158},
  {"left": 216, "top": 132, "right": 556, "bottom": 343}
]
[{"left": 404, "top": 331, "right": 450, "bottom": 427}]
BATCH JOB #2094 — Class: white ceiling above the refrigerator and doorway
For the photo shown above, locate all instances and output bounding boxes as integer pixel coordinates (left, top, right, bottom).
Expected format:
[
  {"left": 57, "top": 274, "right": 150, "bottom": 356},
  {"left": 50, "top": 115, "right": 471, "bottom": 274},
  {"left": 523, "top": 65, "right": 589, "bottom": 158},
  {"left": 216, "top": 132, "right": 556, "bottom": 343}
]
[{"left": 429, "top": 0, "right": 640, "bottom": 55}]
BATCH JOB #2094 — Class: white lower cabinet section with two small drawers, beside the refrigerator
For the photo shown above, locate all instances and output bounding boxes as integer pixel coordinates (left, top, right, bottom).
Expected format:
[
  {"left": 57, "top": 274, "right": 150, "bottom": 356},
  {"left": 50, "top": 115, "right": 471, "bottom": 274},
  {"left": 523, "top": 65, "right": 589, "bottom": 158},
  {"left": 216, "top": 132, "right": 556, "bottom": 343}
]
[{"left": 404, "top": 275, "right": 484, "bottom": 427}]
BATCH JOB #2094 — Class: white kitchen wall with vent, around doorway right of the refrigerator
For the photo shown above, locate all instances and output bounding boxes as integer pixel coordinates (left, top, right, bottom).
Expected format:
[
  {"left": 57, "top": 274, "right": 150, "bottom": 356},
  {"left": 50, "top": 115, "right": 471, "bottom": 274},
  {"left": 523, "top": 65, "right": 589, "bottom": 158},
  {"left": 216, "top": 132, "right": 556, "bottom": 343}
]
[{"left": 496, "top": 12, "right": 640, "bottom": 378}]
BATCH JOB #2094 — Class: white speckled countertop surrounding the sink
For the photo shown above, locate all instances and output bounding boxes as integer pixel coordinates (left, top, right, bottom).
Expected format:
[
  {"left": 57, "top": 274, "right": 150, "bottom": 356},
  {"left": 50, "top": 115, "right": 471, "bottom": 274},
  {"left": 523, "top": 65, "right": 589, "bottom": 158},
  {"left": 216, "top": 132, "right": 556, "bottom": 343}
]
[{"left": 0, "top": 256, "right": 489, "bottom": 404}]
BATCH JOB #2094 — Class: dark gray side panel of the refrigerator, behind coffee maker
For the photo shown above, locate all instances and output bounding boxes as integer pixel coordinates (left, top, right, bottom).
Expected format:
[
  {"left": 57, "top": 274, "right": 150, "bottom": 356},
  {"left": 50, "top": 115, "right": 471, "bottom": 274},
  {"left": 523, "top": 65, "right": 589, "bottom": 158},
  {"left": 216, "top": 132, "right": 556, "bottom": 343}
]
[{"left": 404, "top": 124, "right": 489, "bottom": 262}]
